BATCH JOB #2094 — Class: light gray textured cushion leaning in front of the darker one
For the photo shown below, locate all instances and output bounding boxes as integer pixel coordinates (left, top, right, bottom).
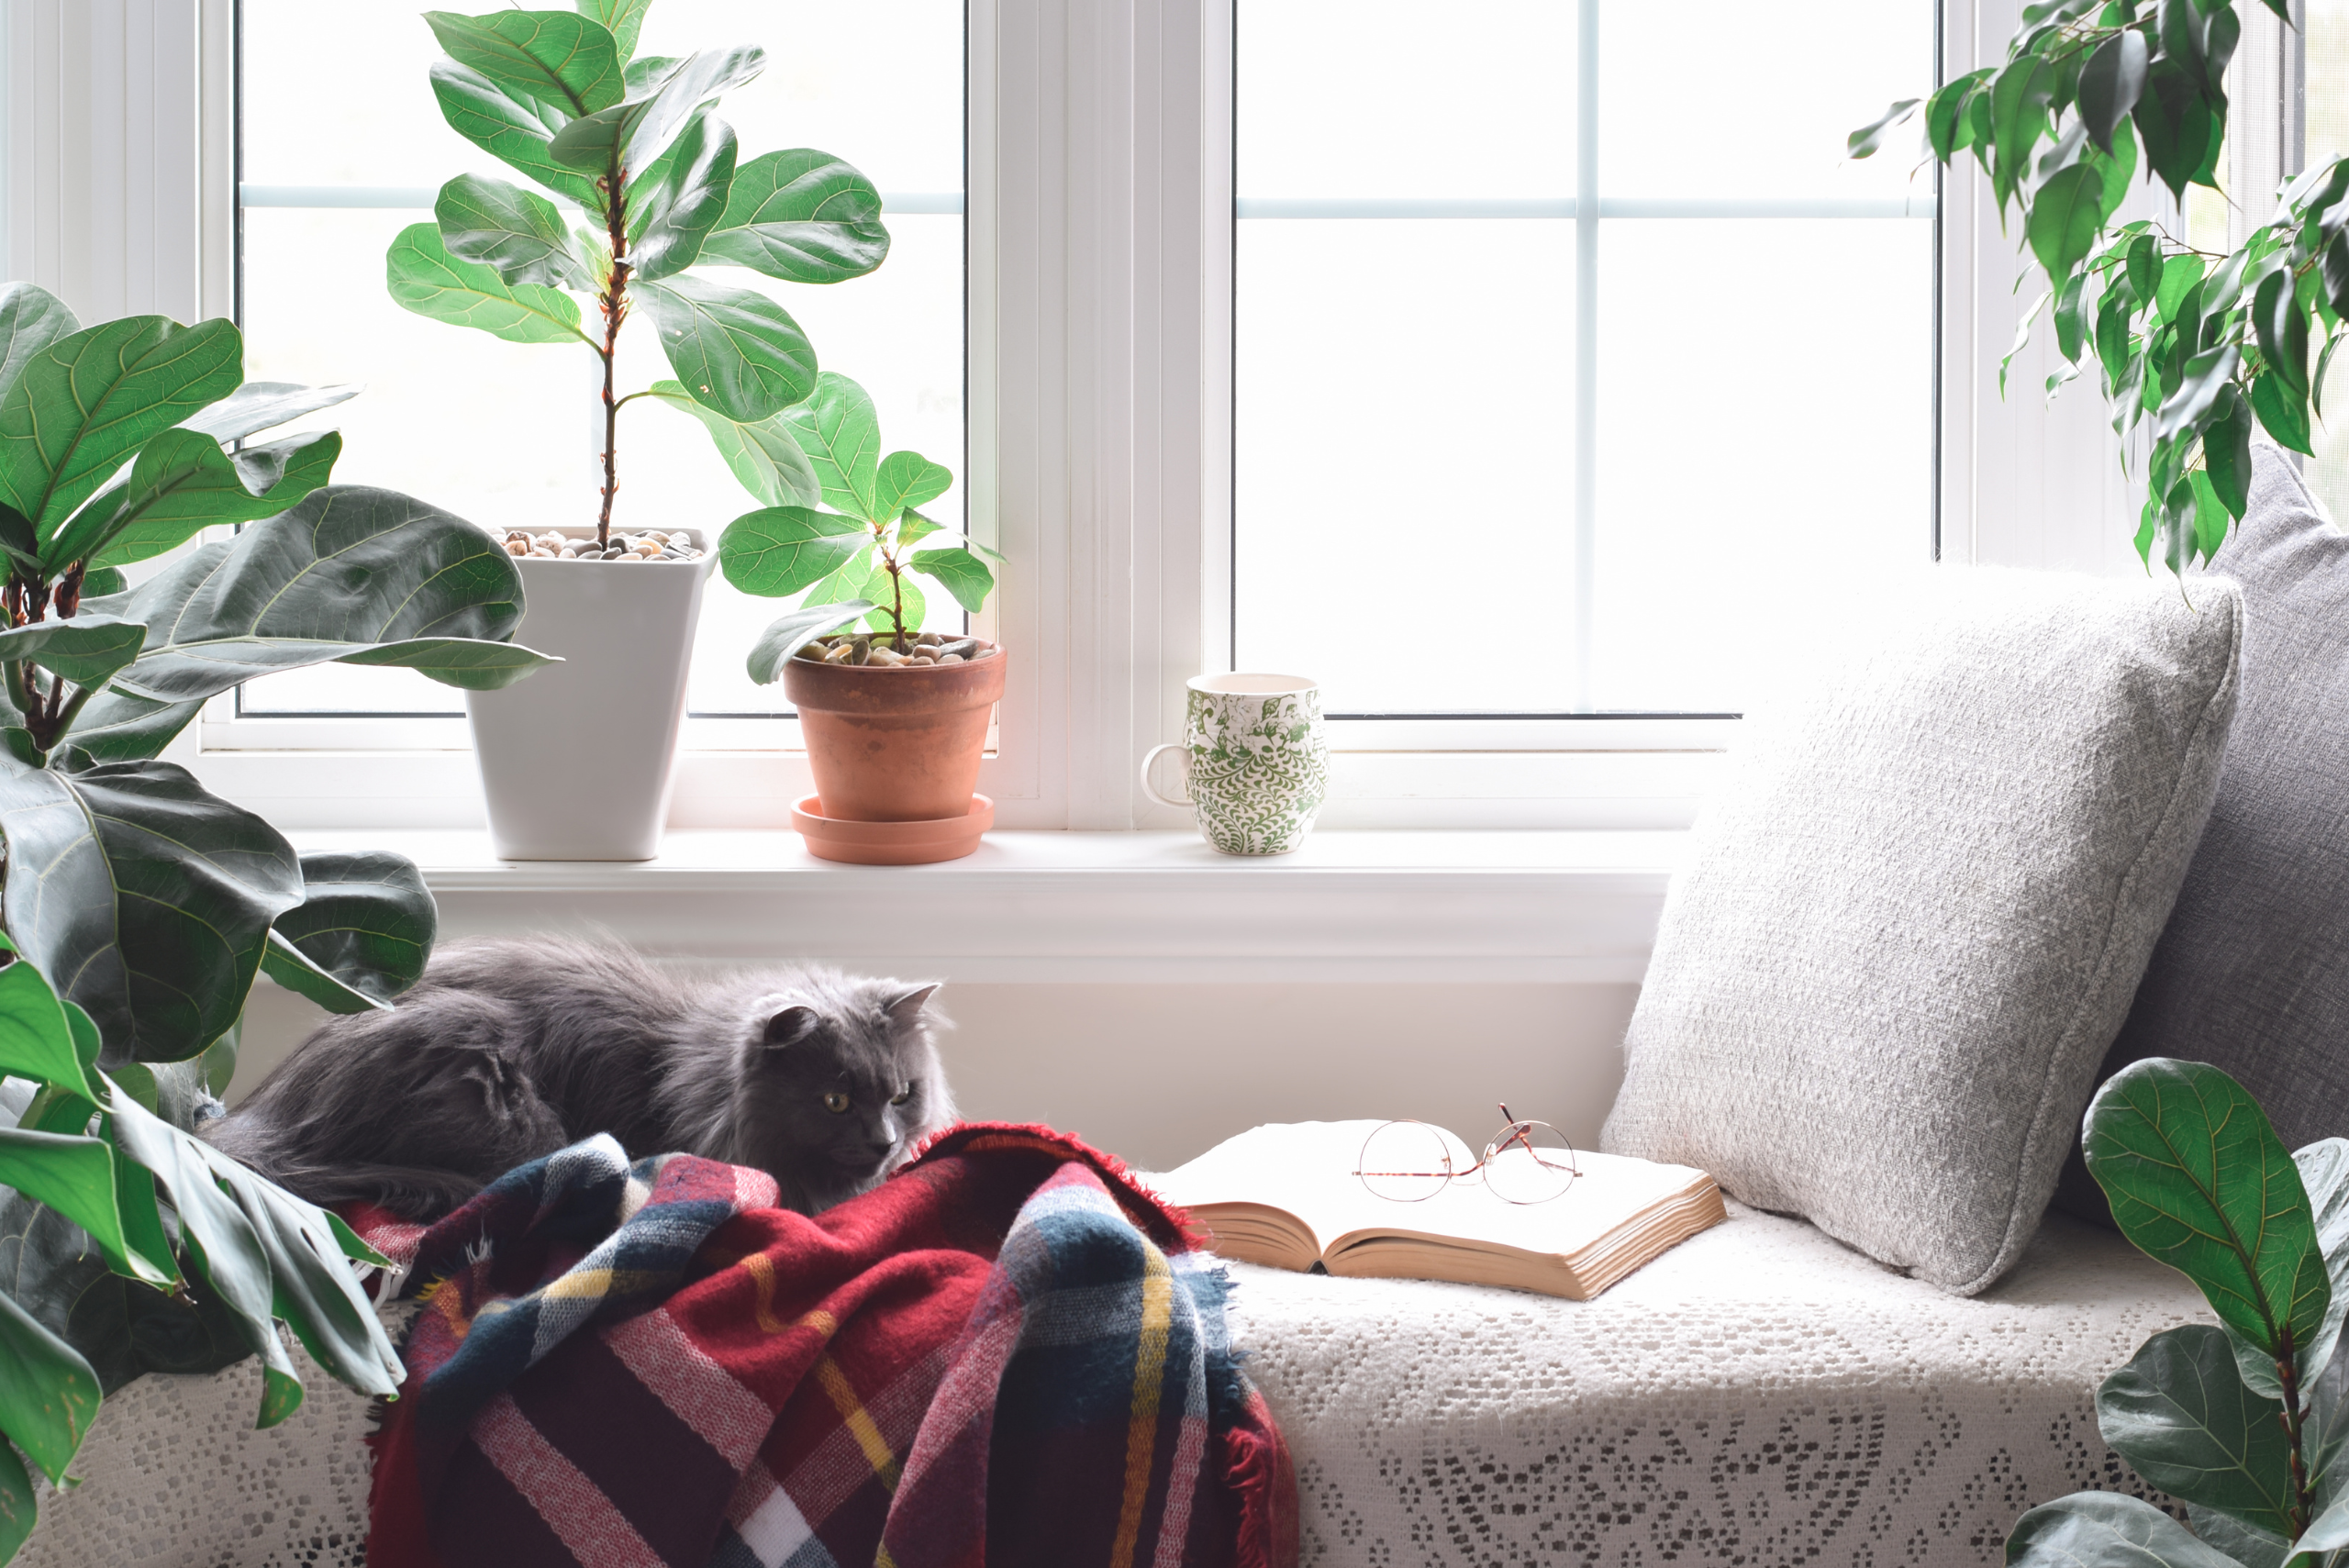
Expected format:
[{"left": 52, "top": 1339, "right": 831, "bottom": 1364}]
[{"left": 1602, "top": 568, "right": 2241, "bottom": 1294}]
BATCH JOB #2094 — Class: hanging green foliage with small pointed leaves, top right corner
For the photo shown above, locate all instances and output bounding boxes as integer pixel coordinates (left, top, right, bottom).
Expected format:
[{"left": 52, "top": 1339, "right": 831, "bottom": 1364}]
[{"left": 1849, "top": 0, "right": 2349, "bottom": 571}]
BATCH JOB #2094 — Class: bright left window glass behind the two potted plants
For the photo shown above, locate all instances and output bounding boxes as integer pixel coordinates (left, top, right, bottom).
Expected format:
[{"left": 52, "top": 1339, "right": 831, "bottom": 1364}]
[{"left": 239, "top": 0, "right": 968, "bottom": 747}]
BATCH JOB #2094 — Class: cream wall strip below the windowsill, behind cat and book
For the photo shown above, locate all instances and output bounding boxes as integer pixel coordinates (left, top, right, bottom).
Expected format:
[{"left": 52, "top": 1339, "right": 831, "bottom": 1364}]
[{"left": 228, "top": 981, "right": 1640, "bottom": 1169}]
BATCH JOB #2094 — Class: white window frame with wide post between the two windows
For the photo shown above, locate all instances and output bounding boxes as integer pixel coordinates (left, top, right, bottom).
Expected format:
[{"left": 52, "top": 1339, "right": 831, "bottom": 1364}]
[{"left": 0, "top": 0, "right": 2135, "bottom": 831}]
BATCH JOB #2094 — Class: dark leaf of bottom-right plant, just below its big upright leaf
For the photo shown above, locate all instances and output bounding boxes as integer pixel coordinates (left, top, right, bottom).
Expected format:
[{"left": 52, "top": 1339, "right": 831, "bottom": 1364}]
[{"left": 2096, "top": 1324, "right": 2293, "bottom": 1535}]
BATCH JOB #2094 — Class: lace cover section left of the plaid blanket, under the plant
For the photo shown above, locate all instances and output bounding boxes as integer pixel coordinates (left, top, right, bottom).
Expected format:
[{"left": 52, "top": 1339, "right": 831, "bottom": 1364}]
[{"left": 12, "top": 1303, "right": 414, "bottom": 1568}]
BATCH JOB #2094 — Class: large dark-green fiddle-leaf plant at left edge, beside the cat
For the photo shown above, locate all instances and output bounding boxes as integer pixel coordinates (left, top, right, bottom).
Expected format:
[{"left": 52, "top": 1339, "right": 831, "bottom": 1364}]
[{"left": 0, "top": 284, "right": 547, "bottom": 1559}]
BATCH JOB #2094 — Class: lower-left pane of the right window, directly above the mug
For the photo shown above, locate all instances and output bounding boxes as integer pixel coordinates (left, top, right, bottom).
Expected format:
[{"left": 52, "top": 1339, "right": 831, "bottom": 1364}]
[{"left": 1233, "top": 218, "right": 1574, "bottom": 714}]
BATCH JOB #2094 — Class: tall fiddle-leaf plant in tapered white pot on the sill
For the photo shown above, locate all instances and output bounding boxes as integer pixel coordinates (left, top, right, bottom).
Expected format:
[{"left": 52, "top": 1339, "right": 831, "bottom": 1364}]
[{"left": 387, "top": 0, "right": 888, "bottom": 859}]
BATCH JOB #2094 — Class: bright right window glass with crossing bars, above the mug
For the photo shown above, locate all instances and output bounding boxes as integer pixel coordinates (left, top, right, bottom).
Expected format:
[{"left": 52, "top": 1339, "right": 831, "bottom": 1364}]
[{"left": 1230, "top": 0, "right": 1935, "bottom": 716}]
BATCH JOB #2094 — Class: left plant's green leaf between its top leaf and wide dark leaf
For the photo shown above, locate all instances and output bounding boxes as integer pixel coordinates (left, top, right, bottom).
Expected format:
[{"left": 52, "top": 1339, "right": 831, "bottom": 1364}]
[{"left": 42, "top": 429, "right": 343, "bottom": 573}]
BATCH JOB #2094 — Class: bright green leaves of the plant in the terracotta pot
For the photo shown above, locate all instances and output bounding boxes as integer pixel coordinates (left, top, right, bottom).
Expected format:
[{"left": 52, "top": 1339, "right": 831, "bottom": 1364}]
[{"left": 718, "top": 371, "right": 1003, "bottom": 685}]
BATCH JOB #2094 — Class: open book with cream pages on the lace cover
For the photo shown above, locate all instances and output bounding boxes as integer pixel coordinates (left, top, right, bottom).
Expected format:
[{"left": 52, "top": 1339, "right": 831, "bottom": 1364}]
[{"left": 1146, "top": 1122, "right": 1727, "bottom": 1300}]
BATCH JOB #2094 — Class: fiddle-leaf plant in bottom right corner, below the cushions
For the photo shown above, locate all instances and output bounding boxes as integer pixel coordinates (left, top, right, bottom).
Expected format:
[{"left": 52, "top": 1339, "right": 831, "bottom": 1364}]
[{"left": 2006, "top": 1059, "right": 2349, "bottom": 1568}]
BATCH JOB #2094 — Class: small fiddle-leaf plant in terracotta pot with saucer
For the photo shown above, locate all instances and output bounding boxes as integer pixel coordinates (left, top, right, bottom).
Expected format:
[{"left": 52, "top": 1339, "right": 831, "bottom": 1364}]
[{"left": 718, "top": 371, "right": 1003, "bottom": 866}]
